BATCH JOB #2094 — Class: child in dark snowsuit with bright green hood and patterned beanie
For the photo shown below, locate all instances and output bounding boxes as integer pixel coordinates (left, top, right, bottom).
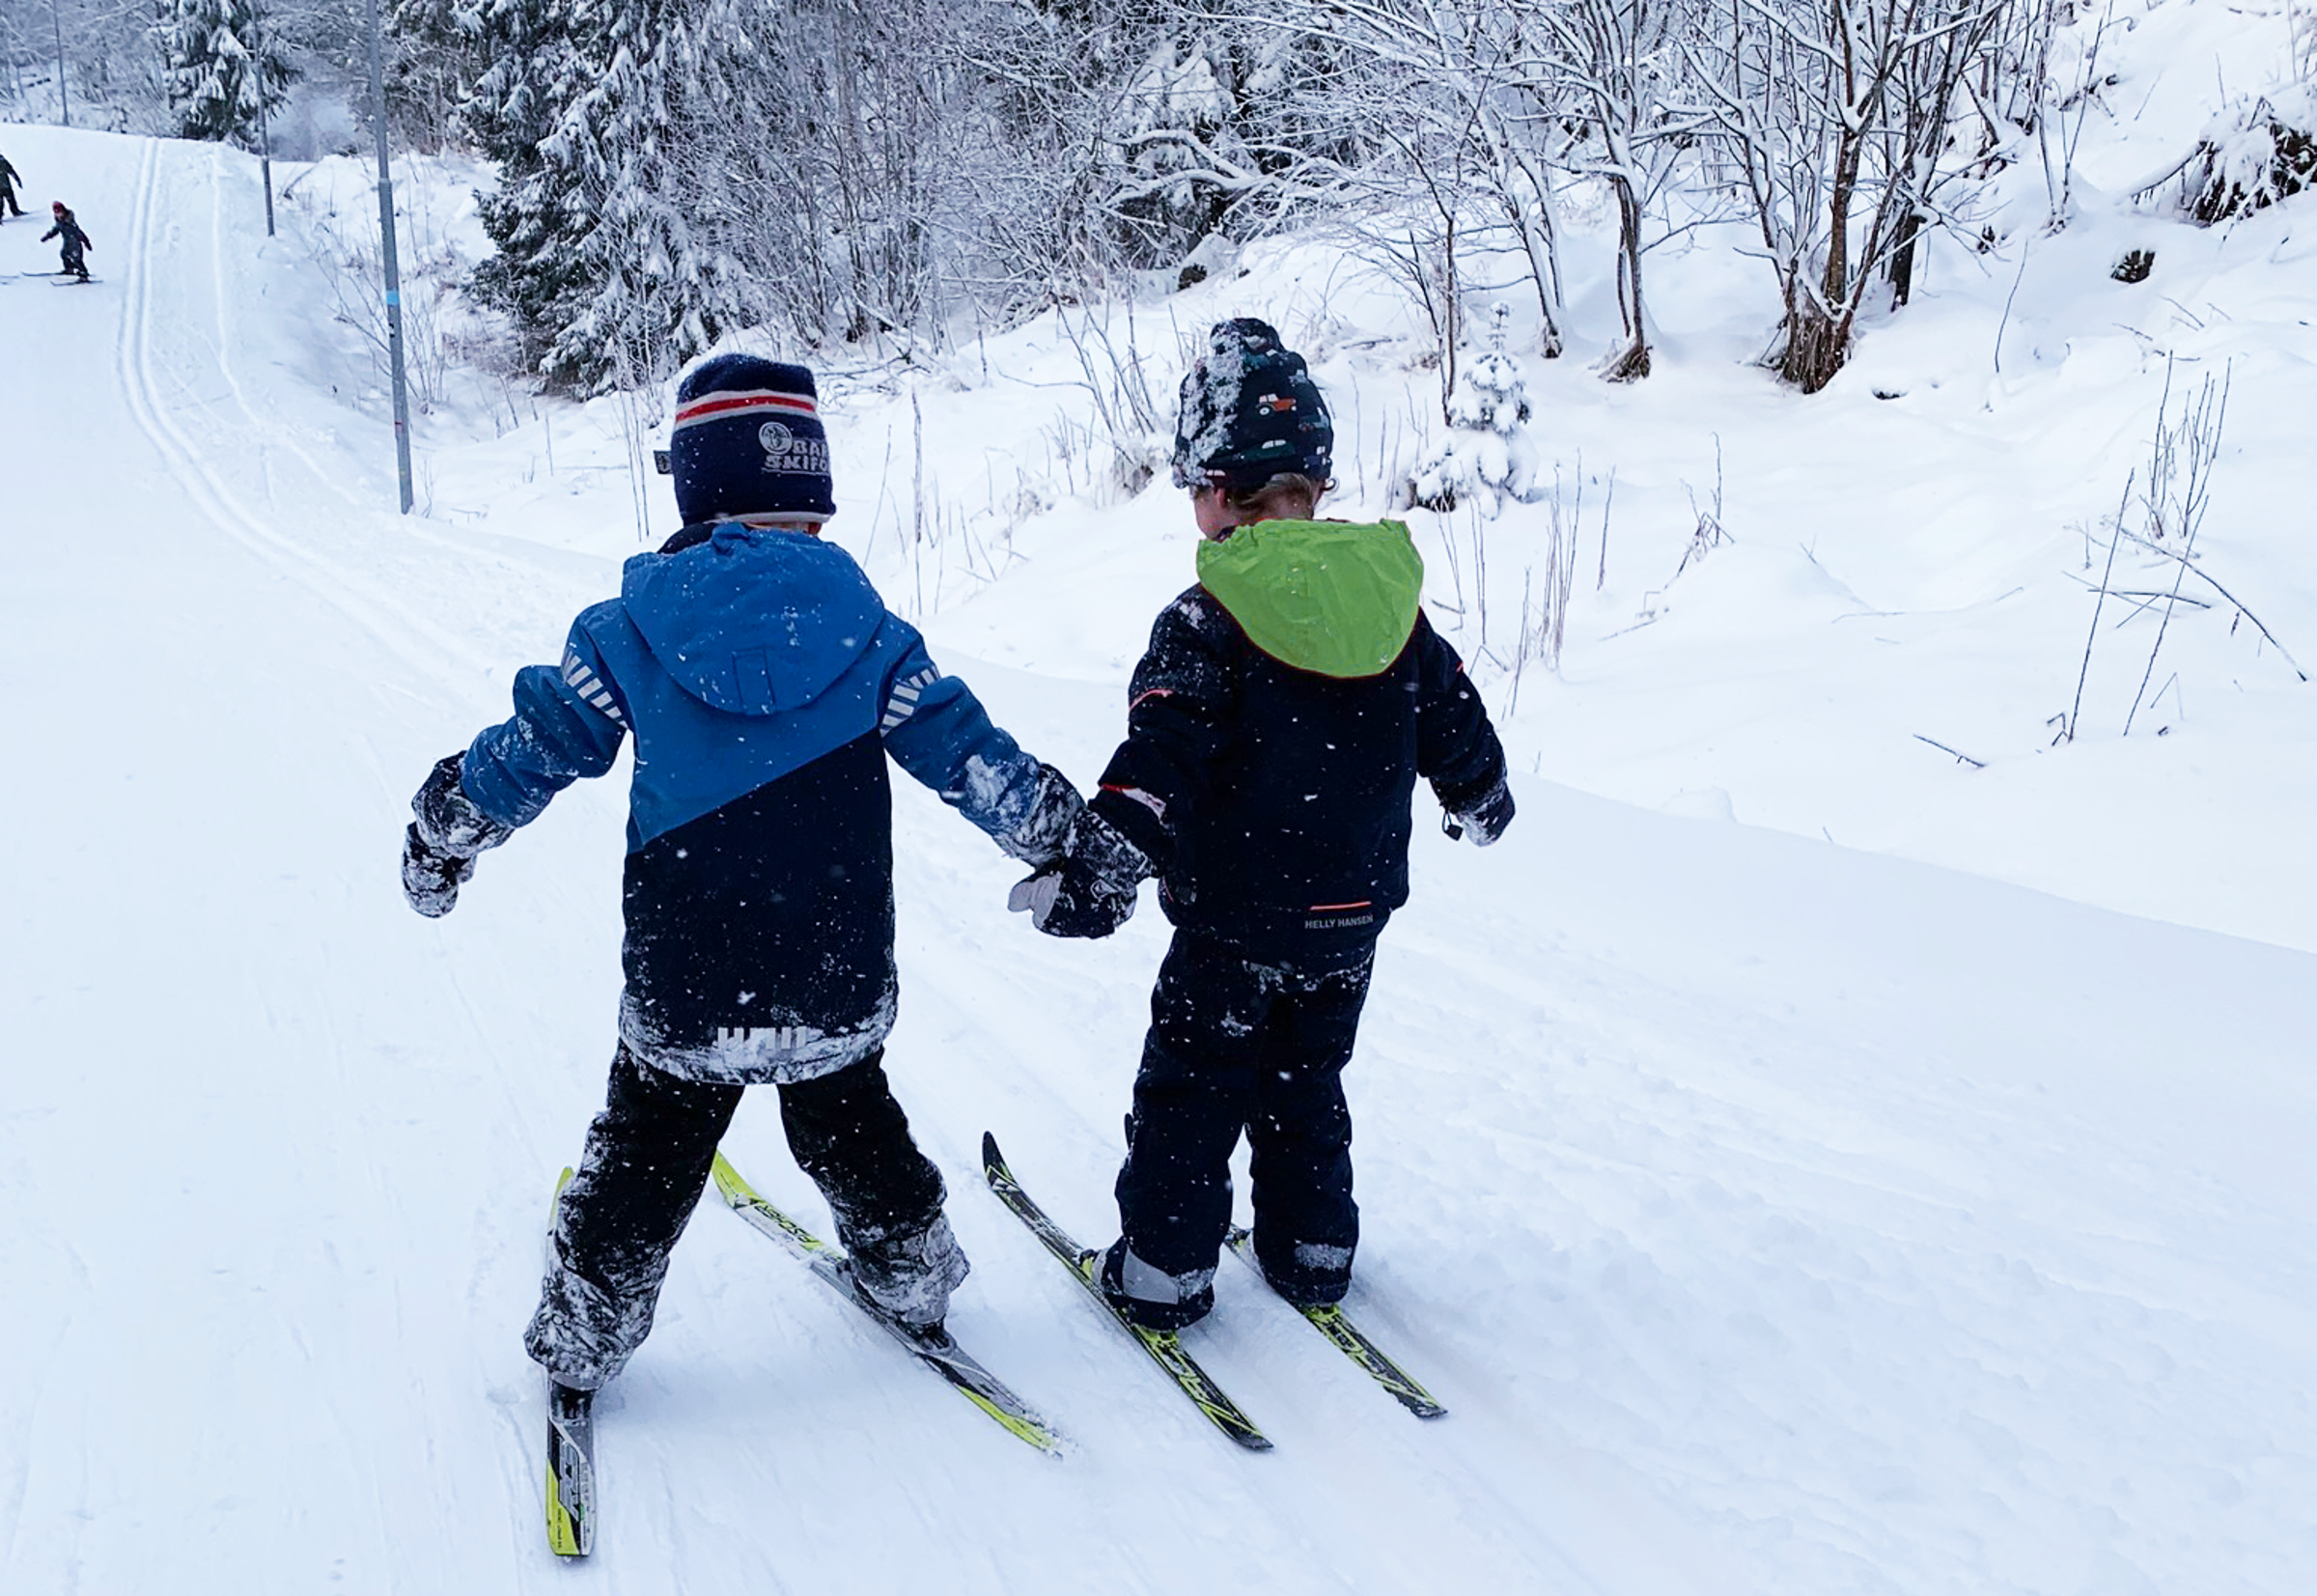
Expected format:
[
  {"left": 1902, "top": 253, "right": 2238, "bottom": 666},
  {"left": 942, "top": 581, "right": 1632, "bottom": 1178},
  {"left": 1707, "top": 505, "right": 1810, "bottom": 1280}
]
[{"left": 1010, "top": 318, "right": 1513, "bottom": 1330}]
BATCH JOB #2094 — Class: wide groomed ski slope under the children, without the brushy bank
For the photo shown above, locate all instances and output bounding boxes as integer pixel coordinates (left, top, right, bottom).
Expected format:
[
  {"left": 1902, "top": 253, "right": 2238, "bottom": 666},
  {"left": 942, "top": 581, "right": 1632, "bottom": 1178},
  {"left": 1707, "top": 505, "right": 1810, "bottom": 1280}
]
[{"left": 0, "top": 127, "right": 2317, "bottom": 1596}]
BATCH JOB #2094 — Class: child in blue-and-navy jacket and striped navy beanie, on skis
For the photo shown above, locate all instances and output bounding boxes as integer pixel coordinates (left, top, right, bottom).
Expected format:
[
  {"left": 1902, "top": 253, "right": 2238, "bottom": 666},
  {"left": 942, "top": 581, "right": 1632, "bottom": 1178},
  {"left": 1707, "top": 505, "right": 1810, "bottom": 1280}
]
[{"left": 404, "top": 354, "right": 1082, "bottom": 1389}]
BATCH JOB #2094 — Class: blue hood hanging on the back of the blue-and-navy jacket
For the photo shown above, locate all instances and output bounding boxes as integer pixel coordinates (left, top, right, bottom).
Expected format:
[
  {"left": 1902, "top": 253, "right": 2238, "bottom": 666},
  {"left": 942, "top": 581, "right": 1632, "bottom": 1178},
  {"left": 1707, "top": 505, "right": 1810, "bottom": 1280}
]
[{"left": 621, "top": 521, "right": 885, "bottom": 715}]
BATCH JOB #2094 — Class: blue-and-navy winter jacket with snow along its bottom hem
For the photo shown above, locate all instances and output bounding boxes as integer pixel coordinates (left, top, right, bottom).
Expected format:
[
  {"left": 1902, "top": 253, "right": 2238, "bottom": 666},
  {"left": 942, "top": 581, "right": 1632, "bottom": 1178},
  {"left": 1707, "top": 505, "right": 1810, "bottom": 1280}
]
[{"left": 461, "top": 521, "right": 1075, "bottom": 1081}]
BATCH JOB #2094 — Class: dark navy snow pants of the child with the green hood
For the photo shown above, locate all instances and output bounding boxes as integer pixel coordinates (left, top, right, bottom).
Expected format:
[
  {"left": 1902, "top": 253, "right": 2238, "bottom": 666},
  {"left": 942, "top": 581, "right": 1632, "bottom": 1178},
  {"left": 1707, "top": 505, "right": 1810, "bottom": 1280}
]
[{"left": 1117, "top": 931, "right": 1377, "bottom": 1302}]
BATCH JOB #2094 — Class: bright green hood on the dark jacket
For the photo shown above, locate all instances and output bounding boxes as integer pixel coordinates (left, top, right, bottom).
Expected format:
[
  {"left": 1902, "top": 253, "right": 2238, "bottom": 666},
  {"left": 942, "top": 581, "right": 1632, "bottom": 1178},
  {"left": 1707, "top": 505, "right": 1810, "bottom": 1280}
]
[{"left": 1198, "top": 521, "right": 1425, "bottom": 677}]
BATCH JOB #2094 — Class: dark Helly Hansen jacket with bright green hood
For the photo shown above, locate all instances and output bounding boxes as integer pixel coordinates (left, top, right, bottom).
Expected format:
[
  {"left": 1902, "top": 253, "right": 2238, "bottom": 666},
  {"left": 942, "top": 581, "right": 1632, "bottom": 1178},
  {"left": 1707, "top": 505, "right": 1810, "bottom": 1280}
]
[{"left": 1094, "top": 521, "right": 1504, "bottom": 957}]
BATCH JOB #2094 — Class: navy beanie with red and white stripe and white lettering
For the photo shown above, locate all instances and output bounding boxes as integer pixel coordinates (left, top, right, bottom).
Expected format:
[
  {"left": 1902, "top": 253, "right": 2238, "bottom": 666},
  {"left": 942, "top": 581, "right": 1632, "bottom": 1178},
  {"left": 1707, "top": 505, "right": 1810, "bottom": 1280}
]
[{"left": 667, "top": 354, "right": 836, "bottom": 523}]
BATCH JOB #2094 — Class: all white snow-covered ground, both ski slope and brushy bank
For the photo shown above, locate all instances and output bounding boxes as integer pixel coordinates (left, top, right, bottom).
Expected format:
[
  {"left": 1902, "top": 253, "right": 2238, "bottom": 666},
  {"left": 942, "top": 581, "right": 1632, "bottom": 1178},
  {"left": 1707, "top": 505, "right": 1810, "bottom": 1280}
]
[{"left": 0, "top": 0, "right": 2317, "bottom": 1596}]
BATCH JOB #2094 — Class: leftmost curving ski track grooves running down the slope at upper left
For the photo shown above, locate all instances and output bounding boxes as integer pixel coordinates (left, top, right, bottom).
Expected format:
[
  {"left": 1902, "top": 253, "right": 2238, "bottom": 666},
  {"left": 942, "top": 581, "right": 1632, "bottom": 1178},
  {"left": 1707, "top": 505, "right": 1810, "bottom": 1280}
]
[{"left": 116, "top": 139, "right": 491, "bottom": 692}]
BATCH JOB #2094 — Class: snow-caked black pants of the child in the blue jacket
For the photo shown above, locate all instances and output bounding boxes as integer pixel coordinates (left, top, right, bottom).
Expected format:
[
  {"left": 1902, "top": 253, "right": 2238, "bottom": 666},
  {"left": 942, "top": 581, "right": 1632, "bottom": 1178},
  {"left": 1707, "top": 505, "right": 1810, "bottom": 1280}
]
[{"left": 523, "top": 1045, "right": 962, "bottom": 1389}]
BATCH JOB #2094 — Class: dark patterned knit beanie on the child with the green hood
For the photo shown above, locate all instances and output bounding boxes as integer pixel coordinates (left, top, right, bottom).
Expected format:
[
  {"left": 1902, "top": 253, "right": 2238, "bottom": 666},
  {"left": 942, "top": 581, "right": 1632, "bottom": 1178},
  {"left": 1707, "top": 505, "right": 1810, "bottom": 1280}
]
[{"left": 1175, "top": 315, "right": 1334, "bottom": 489}]
